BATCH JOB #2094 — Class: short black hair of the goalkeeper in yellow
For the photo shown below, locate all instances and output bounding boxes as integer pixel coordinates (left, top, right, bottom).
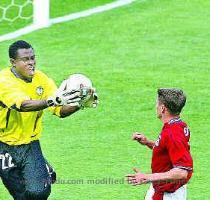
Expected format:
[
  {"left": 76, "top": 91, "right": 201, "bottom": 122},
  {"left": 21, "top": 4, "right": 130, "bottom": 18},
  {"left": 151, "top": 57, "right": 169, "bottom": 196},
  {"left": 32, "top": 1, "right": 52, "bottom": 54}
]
[{"left": 9, "top": 40, "right": 33, "bottom": 59}]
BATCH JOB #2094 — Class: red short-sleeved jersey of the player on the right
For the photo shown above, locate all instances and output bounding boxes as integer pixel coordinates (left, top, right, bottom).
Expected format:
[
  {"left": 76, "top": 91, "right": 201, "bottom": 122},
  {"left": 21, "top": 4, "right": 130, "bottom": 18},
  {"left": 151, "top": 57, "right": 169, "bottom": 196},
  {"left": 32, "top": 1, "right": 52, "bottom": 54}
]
[{"left": 151, "top": 118, "right": 193, "bottom": 200}]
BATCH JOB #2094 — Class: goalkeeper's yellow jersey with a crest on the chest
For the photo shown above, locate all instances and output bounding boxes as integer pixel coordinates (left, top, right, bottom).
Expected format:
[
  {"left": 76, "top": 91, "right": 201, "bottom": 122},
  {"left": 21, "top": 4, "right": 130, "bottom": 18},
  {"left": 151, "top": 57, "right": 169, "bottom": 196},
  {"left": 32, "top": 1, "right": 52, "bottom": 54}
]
[{"left": 0, "top": 68, "right": 60, "bottom": 145}]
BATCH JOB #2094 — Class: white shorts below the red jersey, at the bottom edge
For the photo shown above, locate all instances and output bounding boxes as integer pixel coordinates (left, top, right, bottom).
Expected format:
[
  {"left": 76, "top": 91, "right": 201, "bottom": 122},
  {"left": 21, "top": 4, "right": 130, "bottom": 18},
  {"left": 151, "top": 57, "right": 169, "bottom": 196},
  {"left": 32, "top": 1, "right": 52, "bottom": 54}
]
[{"left": 145, "top": 184, "right": 187, "bottom": 200}]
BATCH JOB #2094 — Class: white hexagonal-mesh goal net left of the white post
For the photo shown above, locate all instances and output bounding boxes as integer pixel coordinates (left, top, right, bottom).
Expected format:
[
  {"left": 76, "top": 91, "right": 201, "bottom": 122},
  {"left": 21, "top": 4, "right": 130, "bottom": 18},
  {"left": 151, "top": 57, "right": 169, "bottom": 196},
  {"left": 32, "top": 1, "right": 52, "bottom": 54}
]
[{"left": 0, "top": 0, "right": 33, "bottom": 22}]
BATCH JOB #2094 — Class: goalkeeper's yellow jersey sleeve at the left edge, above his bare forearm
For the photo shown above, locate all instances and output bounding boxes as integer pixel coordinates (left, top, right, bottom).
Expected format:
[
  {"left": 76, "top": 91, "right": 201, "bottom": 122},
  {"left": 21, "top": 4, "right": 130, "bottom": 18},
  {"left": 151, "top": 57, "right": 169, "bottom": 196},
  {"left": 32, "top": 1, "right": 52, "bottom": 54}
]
[{"left": 0, "top": 80, "right": 30, "bottom": 109}]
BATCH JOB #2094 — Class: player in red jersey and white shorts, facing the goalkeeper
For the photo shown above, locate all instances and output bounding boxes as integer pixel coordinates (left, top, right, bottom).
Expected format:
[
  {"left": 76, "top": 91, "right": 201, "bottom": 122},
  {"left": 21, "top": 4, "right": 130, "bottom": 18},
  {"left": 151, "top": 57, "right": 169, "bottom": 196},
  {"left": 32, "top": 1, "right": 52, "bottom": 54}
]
[{"left": 127, "top": 89, "right": 193, "bottom": 200}]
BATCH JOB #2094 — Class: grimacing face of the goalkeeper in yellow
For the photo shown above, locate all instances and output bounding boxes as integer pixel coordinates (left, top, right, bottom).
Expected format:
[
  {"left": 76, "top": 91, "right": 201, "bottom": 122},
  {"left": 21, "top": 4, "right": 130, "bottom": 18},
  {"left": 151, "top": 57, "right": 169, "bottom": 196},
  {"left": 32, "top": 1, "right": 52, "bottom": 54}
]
[{"left": 11, "top": 48, "right": 36, "bottom": 79}]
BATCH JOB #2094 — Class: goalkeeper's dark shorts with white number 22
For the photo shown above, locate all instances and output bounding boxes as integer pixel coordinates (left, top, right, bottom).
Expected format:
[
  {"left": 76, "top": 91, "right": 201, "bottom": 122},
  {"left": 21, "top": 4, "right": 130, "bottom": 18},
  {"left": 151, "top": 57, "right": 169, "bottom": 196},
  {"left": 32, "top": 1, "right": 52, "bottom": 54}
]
[{"left": 0, "top": 141, "right": 55, "bottom": 200}]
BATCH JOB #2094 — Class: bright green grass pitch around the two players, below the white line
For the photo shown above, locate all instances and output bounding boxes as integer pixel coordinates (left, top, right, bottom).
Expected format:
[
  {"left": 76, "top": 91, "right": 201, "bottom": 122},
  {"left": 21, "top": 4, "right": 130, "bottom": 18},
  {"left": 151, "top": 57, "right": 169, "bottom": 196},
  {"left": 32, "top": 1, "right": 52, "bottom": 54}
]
[{"left": 0, "top": 0, "right": 210, "bottom": 200}]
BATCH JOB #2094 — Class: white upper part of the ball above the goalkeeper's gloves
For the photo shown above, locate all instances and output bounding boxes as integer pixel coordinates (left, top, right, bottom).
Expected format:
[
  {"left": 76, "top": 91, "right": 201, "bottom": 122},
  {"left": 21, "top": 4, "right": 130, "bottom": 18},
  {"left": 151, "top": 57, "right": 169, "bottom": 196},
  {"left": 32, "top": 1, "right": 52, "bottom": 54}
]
[{"left": 66, "top": 74, "right": 93, "bottom": 90}]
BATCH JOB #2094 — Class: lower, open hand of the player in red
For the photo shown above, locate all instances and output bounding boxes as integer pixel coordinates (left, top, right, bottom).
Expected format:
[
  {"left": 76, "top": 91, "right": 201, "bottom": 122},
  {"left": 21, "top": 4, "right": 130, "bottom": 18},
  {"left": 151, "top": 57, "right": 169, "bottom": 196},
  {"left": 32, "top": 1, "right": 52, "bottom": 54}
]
[{"left": 126, "top": 168, "right": 150, "bottom": 186}]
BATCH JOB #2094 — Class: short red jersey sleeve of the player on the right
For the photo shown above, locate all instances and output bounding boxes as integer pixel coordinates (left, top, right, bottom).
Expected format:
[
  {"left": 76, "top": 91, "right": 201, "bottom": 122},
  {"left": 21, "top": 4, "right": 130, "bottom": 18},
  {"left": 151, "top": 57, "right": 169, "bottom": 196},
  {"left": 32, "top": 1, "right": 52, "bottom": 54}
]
[{"left": 165, "top": 127, "right": 193, "bottom": 171}]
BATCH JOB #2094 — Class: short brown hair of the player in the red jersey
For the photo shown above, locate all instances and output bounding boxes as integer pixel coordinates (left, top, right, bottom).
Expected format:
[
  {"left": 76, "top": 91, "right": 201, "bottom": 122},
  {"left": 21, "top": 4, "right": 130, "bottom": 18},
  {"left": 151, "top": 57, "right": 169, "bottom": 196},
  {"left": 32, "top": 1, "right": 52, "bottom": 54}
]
[{"left": 158, "top": 88, "right": 186, "bottom": 115}]
